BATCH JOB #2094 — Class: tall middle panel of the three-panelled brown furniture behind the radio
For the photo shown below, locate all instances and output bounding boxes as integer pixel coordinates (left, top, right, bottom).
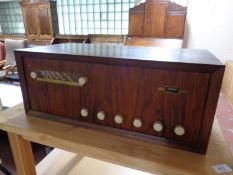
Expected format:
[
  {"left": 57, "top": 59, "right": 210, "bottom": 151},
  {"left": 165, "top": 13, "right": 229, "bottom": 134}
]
[{"left": 144, "top": 2, "right": 168, "bottom": 37}]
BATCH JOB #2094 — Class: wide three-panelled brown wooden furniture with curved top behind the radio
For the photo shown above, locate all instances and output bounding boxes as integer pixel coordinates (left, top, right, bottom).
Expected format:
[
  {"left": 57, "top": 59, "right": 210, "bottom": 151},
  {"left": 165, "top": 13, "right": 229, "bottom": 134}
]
[{"left": 129, "top": 0, "right": 187, "bottom": 38}]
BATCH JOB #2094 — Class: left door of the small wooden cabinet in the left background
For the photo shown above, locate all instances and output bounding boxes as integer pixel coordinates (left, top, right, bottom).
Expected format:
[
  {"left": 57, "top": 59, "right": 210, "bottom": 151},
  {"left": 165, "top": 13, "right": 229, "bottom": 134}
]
[{"left": 22, "top": 7, "right": 38, "bottom": 38}]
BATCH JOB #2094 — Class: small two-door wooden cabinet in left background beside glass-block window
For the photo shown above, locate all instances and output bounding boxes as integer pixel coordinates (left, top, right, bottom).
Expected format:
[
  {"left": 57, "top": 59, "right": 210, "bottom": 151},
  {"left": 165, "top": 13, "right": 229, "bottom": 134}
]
[{"left": 20, "top": 0, "right": 58, "bottom": 45}]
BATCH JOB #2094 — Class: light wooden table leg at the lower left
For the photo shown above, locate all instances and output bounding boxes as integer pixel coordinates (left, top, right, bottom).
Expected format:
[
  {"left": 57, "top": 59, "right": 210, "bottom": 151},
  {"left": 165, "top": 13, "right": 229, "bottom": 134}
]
[{"left": 8, "top": 132, "right": 36, "bottom": 175}]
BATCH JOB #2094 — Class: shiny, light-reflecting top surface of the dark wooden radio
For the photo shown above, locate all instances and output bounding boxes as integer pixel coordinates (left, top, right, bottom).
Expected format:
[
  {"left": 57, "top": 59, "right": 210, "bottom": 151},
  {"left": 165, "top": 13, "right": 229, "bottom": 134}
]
[{"left": 17, "top": 43, "right": 223, "bottom": 66}]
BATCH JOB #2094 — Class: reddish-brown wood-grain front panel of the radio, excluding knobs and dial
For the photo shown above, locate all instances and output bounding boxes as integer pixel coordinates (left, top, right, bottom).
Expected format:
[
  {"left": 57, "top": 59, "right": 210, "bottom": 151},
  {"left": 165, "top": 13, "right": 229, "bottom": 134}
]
[{"left": 25, "top": 58, "right": 209, "bottom": 144}]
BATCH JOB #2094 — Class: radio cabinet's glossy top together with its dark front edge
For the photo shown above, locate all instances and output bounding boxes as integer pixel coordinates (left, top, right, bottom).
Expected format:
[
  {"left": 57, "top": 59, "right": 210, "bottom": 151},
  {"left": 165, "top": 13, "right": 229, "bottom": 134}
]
[{"left": 16, "top": 43, "right": 224, "bottom": 68}]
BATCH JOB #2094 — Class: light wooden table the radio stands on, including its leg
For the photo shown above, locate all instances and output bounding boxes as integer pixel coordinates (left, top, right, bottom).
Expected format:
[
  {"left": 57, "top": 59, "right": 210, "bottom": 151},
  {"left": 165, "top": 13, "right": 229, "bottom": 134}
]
[{"left": 0, "top": 104, "right": 233, "bottom": 175}]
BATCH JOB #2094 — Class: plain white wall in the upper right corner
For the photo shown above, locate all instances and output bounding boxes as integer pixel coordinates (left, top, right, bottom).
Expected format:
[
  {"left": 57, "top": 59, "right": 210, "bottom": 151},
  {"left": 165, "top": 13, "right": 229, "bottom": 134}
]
[{"left": 185, "top": 0, "right": 233, "bottom": 62}]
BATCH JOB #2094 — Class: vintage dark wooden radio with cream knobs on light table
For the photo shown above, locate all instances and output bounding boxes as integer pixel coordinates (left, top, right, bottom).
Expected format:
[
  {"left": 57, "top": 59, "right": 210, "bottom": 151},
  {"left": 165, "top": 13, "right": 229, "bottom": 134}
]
[{"left": 15, "top": 43, "right": 224, "bottom": 153}]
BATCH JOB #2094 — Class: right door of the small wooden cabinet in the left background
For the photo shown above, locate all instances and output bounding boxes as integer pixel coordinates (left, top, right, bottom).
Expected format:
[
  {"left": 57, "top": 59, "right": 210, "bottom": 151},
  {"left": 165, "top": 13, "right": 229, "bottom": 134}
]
[{"left": 37, "top": 5, "right": 53, "bottom": 37}]
